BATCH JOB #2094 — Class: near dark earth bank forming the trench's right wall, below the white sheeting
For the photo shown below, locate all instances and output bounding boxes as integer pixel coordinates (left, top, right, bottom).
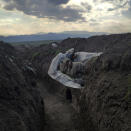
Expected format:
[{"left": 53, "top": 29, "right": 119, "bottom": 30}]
[{"left": 75, "top": 41, "right": 131, "bottom": 131}]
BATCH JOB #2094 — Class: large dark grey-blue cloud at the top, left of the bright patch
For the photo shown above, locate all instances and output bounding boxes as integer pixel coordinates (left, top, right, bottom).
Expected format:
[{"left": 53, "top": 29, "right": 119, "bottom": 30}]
[{"left": 4, "top": 0, "right": 85, "bottom": 22}]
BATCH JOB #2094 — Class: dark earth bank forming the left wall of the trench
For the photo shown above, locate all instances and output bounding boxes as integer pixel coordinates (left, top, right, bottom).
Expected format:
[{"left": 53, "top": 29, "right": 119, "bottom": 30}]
[{"left": 0, "top": 42, "right": 44, "bottom": 131}]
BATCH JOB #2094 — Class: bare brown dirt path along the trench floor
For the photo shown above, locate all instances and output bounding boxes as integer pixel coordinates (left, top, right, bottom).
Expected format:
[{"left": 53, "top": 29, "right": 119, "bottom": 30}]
[{"left": 38, "top": 82, "right": 74, "bottom": 131}]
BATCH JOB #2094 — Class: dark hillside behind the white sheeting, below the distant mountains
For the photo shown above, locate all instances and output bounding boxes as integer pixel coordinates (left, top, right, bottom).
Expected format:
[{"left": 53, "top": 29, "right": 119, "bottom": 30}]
[{"left": 20, "top": 33, "right": 131, "bottom": 79}]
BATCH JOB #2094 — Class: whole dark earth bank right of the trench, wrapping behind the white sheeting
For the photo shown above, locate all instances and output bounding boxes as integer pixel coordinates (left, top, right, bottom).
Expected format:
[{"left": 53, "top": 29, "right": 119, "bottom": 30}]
[{"left": 10, "top": 33, "right": 131, "bottom": 131}]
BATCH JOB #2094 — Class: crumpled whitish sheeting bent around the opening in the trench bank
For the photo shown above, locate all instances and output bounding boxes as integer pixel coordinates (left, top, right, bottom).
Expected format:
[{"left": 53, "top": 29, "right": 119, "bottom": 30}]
[{"left": 48, "top": 48, "right": 102, "bottom": 88}]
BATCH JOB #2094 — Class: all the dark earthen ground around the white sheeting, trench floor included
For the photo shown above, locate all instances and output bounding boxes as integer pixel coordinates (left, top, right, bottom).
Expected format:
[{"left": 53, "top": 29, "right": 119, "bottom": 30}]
[{"left": 0, "top": 33, "right": 131, "bottom": 131}]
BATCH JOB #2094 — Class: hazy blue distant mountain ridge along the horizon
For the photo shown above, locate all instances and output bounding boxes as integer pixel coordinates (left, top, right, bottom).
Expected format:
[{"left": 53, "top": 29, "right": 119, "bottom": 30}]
[{"left": 0, "top": 31, "right": 107, "bottom": 43}]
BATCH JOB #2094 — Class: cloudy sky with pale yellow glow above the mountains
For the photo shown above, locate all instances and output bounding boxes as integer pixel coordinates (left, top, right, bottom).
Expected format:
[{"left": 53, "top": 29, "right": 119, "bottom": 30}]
[{"left": 0, "top": 0, "right": 131, "bottom": 35}]
